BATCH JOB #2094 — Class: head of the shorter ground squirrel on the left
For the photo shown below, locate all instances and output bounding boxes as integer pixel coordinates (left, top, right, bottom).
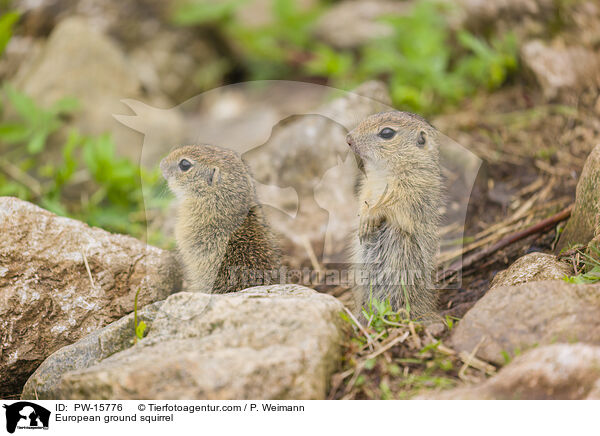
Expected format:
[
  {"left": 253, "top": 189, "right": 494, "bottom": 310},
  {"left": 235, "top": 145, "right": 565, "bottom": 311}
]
[{"left": 160, "top": 145, "right": 255, "bottom": 214}]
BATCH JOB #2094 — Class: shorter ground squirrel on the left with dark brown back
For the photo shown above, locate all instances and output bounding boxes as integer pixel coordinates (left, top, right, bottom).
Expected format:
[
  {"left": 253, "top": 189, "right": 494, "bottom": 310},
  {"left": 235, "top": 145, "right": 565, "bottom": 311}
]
[{"left": 160, "top": 145, "right": 280, "bottom": 293}]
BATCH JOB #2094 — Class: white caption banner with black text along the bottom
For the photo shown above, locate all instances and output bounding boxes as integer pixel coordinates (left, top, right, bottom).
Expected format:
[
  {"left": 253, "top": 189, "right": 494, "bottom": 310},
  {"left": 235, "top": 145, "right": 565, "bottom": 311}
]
[{"left": 0, "top": 400, "right": 600, "bottom": 436}]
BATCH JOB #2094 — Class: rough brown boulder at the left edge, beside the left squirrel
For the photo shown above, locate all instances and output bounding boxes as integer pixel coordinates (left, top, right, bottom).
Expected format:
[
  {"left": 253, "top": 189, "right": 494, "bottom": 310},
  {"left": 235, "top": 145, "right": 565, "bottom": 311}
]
[{"left": 0, "top": 197, "right": 181, "bottom": 397}]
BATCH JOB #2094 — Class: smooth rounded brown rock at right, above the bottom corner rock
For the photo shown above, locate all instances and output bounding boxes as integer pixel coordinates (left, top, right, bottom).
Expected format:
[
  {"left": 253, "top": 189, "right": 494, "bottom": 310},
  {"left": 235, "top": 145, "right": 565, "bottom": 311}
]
[{"left": 450, "top": 280, "right": 600, "bottom": 364}]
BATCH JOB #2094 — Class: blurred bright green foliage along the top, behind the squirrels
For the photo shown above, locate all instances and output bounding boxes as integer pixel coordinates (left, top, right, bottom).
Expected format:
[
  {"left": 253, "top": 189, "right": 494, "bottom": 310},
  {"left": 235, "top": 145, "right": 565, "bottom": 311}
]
[{"left": 173, "top": 0, "right": 517, "bottom": 114}]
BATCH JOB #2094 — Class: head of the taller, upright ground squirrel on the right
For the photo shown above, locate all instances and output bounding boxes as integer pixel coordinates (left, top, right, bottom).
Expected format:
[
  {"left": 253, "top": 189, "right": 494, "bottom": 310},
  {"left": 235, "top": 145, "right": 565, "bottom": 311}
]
[{"left": 346, "top": 111, "right": 439, "bottom": 170}]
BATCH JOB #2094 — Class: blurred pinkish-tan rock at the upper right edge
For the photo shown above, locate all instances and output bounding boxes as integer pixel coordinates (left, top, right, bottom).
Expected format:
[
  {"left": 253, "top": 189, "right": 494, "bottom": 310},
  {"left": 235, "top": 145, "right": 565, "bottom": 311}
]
[{"left": 521, "top": 40, "right": 600, "bottom": 100}]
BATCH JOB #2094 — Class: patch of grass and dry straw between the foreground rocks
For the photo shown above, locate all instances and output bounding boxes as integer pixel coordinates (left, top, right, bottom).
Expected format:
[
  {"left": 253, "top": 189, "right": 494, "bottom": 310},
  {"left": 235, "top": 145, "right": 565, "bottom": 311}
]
[{"left": 330, "top": 295, "right": 476, "bottom": 399}]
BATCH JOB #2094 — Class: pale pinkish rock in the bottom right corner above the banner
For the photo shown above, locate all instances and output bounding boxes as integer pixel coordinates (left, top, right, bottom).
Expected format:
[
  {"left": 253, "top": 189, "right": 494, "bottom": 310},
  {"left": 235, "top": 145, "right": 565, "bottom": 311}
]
[{"left": 420, "top": 344, "right": 600, "bottom": 400}]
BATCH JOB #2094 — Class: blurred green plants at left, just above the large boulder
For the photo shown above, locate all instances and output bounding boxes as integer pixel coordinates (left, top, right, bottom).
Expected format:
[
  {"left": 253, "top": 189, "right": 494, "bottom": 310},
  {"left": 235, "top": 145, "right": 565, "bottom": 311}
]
[{"left": 0, "top": 84, "right": 166, "bottom": 242}]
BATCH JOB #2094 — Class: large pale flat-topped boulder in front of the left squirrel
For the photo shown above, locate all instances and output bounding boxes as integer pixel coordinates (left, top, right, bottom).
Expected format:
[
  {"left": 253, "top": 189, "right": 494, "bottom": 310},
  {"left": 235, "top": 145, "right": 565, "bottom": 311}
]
[{"left": 23, "top": 285, "right": 348, "bottom": 399}]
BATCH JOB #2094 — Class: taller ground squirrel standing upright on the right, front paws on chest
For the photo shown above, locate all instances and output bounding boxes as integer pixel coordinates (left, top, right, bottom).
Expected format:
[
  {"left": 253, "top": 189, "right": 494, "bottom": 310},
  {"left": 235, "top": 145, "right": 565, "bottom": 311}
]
[{"left": 346, "top": 112, "right": 442, "bottom": 318}]
